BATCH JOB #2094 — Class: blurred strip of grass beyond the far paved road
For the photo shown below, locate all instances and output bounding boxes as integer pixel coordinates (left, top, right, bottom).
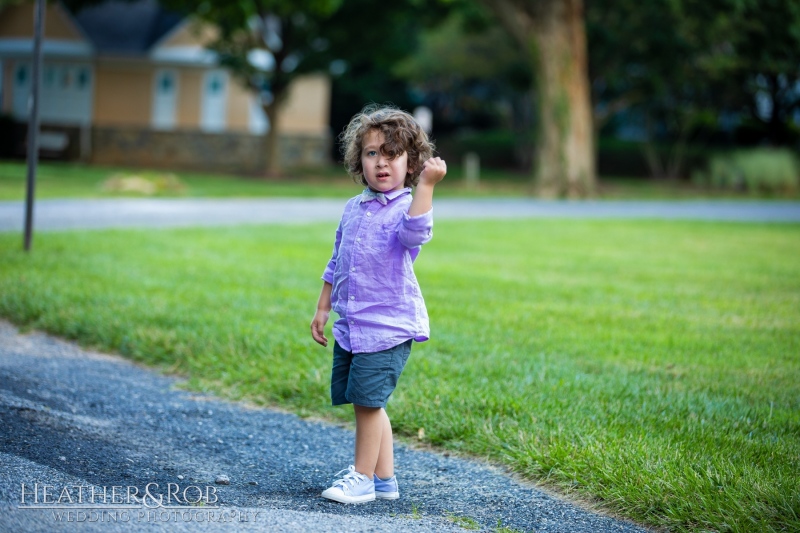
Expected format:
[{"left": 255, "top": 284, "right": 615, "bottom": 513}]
[{"left": 0, "top": 161, "right": 800, "bottom": 201}]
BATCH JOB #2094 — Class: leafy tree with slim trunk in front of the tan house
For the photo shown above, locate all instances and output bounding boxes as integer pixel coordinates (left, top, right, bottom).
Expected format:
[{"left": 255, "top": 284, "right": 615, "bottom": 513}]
[{"left": 160, "top": 0, "right": 446, "bottom": 174}]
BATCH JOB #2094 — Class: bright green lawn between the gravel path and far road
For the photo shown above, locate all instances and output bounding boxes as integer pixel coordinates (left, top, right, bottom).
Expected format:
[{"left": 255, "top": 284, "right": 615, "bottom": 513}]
[{"left": 0, "top": 220, "right": 800, "bottom": 531}]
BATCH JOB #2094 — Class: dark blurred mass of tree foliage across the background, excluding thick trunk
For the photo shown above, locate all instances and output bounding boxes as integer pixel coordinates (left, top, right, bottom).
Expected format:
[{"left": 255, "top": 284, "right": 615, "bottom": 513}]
[{"left": 32, "top": 0, "right": 800, "bottom": 190}]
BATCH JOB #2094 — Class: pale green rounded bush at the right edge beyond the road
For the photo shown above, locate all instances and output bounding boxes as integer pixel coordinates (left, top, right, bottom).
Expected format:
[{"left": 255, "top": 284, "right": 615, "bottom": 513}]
[{"left": 692, "top": 148, "right": 800, "bottom": 192}]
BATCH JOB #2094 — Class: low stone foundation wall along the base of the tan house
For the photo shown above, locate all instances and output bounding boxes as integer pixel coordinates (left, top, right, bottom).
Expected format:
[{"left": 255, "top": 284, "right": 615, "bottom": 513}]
[{"left": 90, "top": 127, "right": 332, "bottom": 174}]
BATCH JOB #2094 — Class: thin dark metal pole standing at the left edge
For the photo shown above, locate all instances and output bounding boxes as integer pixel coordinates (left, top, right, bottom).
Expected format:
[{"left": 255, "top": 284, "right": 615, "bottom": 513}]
[{"left": 25, "top": 0, "right": 45, "bottom": 252}]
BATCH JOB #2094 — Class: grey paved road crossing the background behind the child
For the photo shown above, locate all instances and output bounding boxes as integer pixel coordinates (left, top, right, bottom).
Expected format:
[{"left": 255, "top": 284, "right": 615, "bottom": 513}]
[{"left": 0, "top": 198, "right": 800, "bottom": 231}]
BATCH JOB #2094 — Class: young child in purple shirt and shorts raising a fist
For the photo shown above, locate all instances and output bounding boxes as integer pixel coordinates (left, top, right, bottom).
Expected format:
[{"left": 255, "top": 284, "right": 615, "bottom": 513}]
[{"left": 311, "top": 105, "right": 447, "bottom": 503}]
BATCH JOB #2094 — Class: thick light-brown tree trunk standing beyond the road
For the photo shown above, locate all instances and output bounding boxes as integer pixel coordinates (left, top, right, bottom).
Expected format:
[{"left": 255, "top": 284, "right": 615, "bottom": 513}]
[{"left": 486, "top": 0, "right": 596, "bottom": 197}]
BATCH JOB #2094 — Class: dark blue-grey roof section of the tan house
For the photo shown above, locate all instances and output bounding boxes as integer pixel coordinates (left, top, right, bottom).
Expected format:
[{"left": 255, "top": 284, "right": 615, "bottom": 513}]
[{"left": 73, "top": 0, "right": 184, "bottom": 56}]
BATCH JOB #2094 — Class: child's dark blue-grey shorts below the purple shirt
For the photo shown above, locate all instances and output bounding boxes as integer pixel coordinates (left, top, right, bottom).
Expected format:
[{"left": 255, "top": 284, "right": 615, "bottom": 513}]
[{"left": 331, "top": 340, "right": 411, "bottom": 407}]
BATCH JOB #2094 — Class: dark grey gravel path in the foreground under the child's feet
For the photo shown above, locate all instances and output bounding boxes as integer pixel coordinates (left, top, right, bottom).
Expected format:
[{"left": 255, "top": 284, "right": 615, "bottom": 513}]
[{"left": 0, "top": 321, "right": 645, "bottom": 533}]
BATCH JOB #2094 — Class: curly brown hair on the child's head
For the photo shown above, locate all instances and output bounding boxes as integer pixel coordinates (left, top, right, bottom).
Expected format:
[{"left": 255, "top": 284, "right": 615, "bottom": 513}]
[{"left": 339, "top": 104, "right": 435, "bottom": 187}]
